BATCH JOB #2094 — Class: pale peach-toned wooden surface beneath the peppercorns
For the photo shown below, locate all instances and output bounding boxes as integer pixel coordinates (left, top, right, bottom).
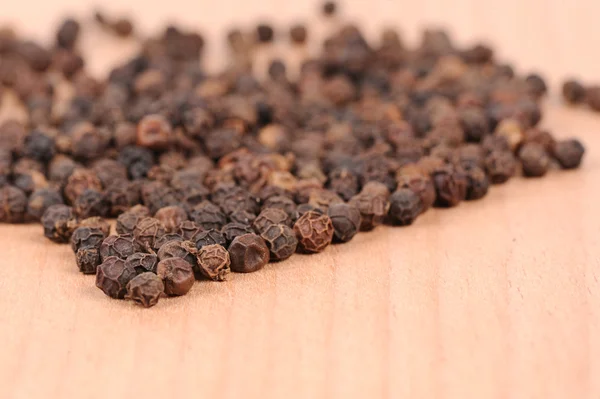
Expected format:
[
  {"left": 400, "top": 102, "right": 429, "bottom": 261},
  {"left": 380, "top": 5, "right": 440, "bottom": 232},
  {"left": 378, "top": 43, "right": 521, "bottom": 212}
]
[{"left": 0, "top": 0, "right": 600, "bottom": 399}]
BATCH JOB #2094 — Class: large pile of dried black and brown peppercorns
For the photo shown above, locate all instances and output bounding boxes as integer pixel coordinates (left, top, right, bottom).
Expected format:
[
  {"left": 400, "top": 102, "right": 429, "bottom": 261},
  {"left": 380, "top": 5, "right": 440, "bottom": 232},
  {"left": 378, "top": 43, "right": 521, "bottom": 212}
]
[{"left": 0, "top": 2, "right": 584, "bottom": 307}]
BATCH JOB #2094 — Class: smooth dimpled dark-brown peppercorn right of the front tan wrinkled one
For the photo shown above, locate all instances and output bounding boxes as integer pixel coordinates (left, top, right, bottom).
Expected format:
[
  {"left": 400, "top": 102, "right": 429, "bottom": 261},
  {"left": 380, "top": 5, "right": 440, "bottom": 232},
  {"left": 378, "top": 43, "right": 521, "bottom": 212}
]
[{"left": 228, "top": 234, "right": 269, "bottom": 273}]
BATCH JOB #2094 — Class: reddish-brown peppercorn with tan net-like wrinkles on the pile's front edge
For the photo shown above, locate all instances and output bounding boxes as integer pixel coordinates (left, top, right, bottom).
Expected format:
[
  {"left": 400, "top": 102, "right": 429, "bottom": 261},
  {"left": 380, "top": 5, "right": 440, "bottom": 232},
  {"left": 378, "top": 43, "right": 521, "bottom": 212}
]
[{"left": 294, "top": 212, "right": 333, "bottom": 252}]
